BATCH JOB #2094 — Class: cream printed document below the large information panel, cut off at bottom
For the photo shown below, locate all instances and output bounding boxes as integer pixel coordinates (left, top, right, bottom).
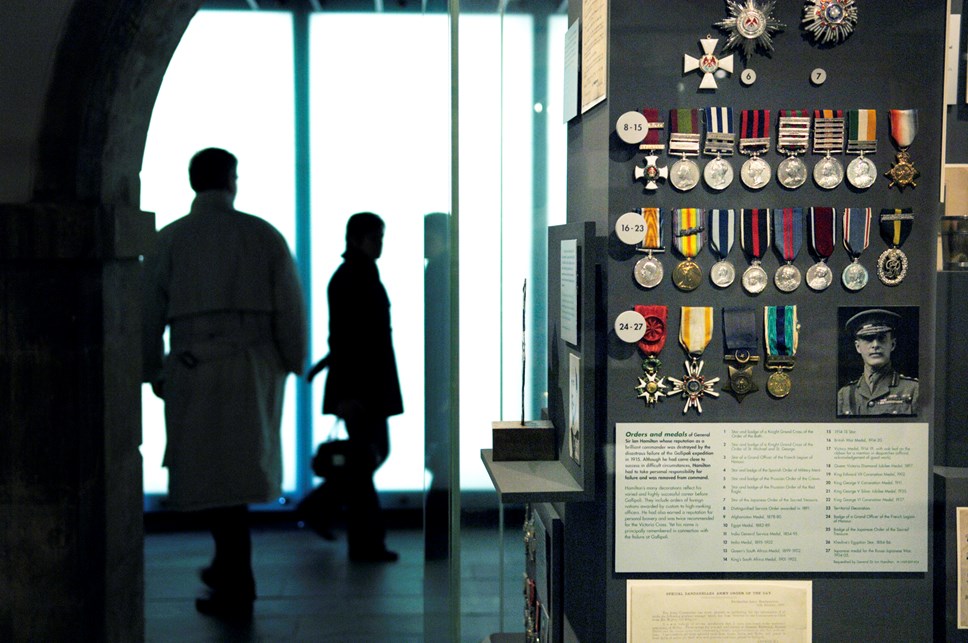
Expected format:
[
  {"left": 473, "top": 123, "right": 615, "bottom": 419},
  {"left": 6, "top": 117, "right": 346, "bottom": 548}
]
[{"left": 625, "top": 580, "right": 813, "bottom": 643}]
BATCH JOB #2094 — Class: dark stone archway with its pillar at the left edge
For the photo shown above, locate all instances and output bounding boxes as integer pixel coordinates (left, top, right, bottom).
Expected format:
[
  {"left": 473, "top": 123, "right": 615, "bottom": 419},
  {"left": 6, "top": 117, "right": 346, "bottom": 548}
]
[{"left": 0, "top": 0, "right": 202, "bottom": 641}]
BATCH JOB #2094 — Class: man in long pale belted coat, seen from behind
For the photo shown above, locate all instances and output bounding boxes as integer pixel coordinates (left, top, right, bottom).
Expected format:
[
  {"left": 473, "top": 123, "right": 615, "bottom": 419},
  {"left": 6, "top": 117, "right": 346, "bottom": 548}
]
[{"left": 143, "top": 148, "right": 307, "bottom": 617}]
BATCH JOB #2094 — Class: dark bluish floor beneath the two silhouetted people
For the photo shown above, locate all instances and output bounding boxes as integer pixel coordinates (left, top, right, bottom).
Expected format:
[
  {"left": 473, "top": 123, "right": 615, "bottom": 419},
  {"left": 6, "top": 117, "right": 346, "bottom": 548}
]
[{"left": 145, "top": 522, "right": 524, "bottom": 643}]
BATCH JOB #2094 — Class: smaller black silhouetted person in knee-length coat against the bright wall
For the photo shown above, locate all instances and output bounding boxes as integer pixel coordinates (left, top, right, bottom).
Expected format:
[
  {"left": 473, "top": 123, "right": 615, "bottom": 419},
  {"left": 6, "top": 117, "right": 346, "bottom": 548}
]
[{"left": 314, "top": 212, "right": 403, "bottom": 562}]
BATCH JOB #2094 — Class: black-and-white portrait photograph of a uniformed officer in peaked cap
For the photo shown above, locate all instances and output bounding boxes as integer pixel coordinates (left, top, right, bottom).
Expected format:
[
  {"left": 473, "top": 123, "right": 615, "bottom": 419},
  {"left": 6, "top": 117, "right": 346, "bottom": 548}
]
[{"left": 837, "top": 306, "right": 919, "bottom": 417}]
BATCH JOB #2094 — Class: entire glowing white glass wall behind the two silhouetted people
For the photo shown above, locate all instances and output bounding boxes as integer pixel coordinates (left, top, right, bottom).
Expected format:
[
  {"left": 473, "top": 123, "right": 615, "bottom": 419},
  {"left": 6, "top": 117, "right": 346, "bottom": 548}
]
[{"left": 142, "top": 11, "right": 565, "bottom": 494}]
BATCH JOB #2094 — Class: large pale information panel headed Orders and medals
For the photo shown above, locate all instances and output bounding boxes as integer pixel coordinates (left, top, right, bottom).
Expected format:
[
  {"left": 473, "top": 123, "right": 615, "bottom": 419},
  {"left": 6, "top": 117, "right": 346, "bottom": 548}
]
[{"left": 615, "top": 423, "right": 928, "bottom": 573}]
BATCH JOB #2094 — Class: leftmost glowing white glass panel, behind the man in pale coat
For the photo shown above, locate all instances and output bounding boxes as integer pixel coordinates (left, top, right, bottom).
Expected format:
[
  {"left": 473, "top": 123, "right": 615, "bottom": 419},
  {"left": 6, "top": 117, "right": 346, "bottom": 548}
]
[{"left": 141, "top": 11, "right": 296, "bottom": 494}]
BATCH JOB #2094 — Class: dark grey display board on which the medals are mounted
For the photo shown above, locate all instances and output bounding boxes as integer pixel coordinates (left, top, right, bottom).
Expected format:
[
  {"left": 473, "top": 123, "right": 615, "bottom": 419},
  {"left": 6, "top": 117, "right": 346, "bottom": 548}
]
[{"left": 549, "top": 0, "right": 946, "bottom": 641}]
